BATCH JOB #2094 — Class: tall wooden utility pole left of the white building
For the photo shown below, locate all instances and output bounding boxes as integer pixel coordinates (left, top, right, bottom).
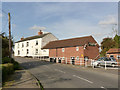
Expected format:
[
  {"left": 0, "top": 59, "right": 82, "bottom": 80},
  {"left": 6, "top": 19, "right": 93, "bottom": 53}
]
[{"left": 8, "top": 13, "right": 12, "bottom": 58}]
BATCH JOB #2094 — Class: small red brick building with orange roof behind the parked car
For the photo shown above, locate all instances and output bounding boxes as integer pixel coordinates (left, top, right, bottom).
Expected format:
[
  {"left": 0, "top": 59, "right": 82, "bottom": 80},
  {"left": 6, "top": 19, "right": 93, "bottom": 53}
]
[{"left": 106, "top": 48, "right": 120, "bottom": 62}]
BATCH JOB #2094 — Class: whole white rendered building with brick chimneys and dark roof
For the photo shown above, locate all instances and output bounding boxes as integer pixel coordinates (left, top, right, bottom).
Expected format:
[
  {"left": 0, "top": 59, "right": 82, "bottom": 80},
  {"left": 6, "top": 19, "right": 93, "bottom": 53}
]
[{"left": 14, "top": 30, "right": 58, "bottom": 57}]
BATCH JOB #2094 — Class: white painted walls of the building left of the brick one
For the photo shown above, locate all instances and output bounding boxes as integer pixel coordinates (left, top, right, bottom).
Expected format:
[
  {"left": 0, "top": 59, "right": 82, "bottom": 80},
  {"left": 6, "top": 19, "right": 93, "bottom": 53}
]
[{"left": 14, "top": 33, "right": 57, "bottom": 57}]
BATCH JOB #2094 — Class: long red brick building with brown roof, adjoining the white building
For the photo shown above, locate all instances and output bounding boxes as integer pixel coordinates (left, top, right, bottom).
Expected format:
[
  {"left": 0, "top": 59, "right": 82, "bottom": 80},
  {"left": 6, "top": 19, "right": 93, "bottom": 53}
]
[{"left": 43, "top": 36, "right": 99, "bottom": 64}]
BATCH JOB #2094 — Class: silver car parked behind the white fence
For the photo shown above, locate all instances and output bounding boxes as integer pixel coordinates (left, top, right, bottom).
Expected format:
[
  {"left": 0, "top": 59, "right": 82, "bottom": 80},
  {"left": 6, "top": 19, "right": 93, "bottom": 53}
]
[{"left": 93, "top": 57, "right": 117, "bottom": 67}]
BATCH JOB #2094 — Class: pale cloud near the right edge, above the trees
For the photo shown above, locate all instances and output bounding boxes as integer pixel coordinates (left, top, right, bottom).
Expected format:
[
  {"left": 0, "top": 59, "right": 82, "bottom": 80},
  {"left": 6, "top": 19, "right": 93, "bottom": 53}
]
[{"left": 98, "top": 15, "right": 117, "bottom": 26}]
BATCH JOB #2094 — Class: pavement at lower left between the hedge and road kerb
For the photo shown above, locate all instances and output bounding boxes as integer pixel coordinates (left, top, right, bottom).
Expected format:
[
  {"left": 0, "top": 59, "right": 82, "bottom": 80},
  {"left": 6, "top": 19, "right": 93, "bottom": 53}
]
[{"left": 3, "top": 70, "right": 39, "bottom": 90}]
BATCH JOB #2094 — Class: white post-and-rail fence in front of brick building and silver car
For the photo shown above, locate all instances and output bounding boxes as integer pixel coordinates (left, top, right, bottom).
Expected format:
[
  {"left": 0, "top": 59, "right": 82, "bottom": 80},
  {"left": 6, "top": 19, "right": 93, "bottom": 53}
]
[{"left": 50, "top": 58, "right": 118, "bottom": 69}]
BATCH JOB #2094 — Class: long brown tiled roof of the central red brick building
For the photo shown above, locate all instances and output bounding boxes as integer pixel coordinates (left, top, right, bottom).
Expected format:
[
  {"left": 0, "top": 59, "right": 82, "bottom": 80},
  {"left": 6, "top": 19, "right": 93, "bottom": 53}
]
[{"left": 43, "top": 36, "right": 99, "bottom": 49}]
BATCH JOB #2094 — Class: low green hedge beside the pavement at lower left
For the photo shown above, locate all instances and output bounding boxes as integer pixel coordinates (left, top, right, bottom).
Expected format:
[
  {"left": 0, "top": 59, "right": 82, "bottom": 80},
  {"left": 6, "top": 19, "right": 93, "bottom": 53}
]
[{"left": 2, "top": 63, "right": 14, "bottom": 82}]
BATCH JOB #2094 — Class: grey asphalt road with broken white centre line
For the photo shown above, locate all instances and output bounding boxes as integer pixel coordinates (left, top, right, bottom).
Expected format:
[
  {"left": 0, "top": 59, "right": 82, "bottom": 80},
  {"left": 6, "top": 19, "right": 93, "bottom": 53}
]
[{"left": 15, "top": 57, "right": 118, "bottom": 89}]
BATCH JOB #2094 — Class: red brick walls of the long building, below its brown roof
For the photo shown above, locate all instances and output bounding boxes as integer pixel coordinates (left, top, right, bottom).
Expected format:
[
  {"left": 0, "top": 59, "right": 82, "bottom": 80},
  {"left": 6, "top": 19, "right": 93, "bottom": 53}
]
[{"left": 49, "top": 46, "right": 99, "bottom": 64}]
